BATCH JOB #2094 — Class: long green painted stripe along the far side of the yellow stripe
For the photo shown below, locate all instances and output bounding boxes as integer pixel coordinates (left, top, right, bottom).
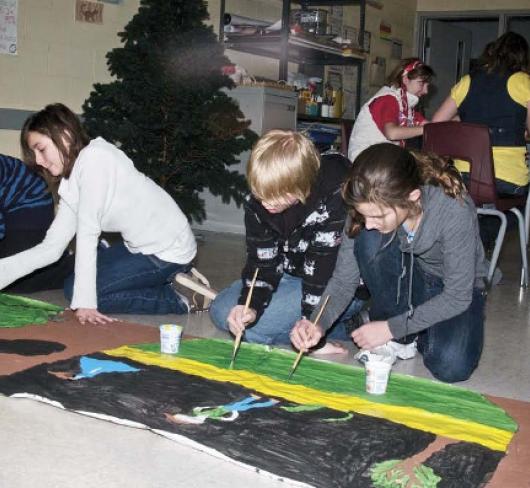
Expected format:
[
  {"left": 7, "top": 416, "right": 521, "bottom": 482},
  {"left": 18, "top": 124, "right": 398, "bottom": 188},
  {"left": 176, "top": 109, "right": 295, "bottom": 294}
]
[{"left": 131, "top": 339, "right": 517, "bottom": 432}]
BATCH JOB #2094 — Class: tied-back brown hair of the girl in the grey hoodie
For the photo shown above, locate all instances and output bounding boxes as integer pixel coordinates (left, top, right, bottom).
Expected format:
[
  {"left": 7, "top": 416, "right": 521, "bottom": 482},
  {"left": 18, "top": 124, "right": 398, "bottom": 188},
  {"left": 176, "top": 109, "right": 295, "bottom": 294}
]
[{"left": 342, "top": 142, "right": 466, "bottom": 236}]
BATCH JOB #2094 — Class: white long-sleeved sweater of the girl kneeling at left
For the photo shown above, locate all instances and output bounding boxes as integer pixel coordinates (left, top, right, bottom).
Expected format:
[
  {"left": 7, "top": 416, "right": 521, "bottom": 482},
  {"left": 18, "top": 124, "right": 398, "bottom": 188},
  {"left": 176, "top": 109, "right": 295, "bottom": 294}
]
[{"left": 0, "top": 137, "right": 197, "bottom": 309}]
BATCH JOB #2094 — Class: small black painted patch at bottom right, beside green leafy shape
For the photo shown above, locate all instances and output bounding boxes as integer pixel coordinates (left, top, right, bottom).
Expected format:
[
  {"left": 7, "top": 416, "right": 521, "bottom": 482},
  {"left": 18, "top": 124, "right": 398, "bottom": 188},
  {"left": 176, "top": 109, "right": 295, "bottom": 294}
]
[{"left": 424, "top": 442, "right": 504, "bottom": 488}]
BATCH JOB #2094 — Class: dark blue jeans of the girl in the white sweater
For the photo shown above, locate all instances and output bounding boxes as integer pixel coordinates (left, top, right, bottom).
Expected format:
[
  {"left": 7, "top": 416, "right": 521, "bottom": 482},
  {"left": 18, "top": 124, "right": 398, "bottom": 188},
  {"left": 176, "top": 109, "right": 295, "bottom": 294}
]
[{"left": 64, "top": 243, "right": 191, "bottom": 315}]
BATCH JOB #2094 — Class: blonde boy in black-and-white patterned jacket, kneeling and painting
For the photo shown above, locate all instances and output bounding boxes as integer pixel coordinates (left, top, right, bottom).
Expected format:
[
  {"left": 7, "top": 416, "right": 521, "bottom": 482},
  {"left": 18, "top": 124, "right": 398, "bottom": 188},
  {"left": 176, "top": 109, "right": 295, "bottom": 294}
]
[{"left": 210, "top": 130, "right": 362, "bottom": 353}]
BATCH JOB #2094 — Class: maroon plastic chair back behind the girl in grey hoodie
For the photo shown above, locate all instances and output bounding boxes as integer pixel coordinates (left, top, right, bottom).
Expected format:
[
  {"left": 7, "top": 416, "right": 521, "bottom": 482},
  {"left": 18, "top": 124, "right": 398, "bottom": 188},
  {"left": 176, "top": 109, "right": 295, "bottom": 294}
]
[{"left": 423, "top": 122, "right": 498, "bottom": 207}]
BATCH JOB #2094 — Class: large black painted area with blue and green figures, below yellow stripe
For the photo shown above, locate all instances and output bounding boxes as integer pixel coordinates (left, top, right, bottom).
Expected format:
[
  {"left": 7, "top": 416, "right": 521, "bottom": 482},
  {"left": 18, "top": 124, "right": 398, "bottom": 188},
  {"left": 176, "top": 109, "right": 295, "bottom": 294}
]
[{"left": 0, "top": 354, "right": 500, "bottom": 488}]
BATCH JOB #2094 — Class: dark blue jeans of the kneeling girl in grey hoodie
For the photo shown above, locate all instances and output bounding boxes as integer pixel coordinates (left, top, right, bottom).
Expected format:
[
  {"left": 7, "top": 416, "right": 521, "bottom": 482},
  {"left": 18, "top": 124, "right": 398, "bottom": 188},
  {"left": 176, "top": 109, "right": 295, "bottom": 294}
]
[{"left": 354, "top": 230, "right": 485, "bottom": 383}]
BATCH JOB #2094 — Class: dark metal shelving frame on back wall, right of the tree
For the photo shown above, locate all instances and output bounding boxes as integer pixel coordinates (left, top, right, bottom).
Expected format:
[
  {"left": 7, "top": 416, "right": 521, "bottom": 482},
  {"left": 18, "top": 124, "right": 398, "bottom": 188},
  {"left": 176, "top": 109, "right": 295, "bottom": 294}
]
[{"left": 219, "top": 0, "right": 366, "bottom": 111}]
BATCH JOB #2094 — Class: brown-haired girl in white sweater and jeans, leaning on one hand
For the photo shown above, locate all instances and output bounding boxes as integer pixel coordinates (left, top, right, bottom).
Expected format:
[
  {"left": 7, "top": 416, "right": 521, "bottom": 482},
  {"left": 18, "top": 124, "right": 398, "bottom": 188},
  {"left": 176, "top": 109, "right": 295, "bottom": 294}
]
[{"left": 0, "top": 104, "right": 196, "bottom": 324}]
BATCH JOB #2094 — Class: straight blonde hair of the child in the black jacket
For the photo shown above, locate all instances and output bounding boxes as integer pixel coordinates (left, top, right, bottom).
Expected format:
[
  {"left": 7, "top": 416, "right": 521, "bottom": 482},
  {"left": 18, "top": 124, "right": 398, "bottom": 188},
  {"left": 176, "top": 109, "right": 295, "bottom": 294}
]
[{"left": 247, "top": 130, "right": 320, "bottom": 203}]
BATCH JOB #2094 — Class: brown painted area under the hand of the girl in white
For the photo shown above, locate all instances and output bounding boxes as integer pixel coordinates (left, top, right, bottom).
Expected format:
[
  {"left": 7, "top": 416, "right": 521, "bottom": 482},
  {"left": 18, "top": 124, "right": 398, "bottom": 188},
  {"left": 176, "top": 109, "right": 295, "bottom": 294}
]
[{"left": 0, "top": 312, "right": 160, "bottom": 375}]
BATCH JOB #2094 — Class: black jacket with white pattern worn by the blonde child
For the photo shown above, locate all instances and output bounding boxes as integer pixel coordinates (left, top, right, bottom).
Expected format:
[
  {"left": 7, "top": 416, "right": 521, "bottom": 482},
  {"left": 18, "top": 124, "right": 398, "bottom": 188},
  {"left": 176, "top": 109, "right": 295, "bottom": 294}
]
[{"left": 238, "top": 154, "right": 350, "bottom": 318}]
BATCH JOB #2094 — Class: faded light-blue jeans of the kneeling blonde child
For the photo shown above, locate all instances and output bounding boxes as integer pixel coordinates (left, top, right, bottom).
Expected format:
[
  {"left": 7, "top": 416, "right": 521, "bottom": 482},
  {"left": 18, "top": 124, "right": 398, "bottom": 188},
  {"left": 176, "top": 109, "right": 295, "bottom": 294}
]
[{"left": 210, "top": 273, "right": 364, "bottom": 344}]
